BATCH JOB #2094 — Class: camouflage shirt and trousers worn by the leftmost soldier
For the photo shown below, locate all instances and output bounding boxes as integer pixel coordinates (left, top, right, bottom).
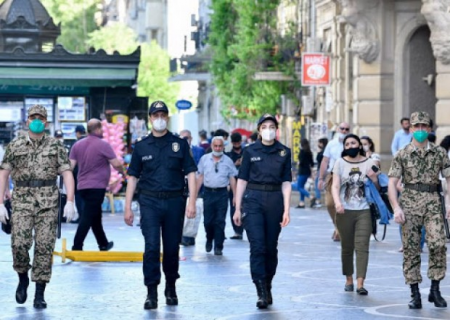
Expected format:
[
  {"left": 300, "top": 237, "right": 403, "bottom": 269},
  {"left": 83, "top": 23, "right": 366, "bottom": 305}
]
[{"left": 0, "top": 112, "right": 71, "bottom": 282}]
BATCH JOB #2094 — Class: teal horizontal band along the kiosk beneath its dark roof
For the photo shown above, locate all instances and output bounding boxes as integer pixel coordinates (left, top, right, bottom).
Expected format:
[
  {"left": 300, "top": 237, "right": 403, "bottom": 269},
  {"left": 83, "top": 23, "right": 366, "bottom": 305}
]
[{"left": 0, "top": 67, "right": 137, "bottom": 87}]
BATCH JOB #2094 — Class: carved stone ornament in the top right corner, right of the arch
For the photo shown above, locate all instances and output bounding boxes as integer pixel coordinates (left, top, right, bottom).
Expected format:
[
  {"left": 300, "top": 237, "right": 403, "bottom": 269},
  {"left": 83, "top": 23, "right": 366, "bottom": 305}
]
[{"left": 421, "top": 0, "right": 450, "bottom": 64}]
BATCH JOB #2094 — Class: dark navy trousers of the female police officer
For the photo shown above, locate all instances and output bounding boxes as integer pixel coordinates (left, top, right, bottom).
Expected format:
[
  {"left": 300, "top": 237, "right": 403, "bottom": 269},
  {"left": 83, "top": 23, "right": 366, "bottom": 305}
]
[{"left": 241, "top": 189, "right": 284, "bottom": 281}]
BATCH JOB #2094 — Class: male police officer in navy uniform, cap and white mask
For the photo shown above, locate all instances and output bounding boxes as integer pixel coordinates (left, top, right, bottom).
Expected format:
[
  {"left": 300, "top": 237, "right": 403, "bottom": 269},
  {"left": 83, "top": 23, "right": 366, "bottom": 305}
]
[{"left": 124, "top": 101, "right": 197, "bottom": 309}]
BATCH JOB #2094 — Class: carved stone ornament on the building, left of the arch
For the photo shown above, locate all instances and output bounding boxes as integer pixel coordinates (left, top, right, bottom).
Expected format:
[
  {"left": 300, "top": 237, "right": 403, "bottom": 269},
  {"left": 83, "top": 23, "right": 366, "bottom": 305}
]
[{"left": 338, "top": 0, "right": 380, "bottom": 63}]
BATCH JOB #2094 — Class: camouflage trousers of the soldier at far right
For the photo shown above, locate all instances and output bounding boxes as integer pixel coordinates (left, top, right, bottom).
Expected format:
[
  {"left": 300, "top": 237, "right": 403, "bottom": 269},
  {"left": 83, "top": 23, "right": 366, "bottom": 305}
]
[{"left": 401, "top": 190, "right": 447, "bottom": 284}]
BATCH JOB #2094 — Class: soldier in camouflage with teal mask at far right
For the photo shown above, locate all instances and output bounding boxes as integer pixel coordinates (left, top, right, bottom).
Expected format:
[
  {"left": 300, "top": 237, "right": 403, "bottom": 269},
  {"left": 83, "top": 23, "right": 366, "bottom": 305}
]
[{"left": 389, "top": 112, "right": 450, "bottom": 309}]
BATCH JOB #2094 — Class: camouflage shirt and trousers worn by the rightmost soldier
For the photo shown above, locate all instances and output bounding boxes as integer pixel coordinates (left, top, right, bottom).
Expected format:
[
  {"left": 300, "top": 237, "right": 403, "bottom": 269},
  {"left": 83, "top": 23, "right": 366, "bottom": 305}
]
[{"left": 389, "top": 136, "right": 450, "bottom": 284}]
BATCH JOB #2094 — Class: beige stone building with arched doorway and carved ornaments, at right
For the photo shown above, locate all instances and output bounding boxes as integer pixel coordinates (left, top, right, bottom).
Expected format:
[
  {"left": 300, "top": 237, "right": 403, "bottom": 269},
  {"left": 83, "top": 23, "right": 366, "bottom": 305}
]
[{"left": 315, "top": 0, "right": 450, "bottom": 160}]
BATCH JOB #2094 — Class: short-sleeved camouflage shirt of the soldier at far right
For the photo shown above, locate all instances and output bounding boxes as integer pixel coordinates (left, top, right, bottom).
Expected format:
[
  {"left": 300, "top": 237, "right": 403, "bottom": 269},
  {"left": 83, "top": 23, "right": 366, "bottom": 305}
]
[{"left": 388, "top": 143, "right": 450, "bottom": 184}]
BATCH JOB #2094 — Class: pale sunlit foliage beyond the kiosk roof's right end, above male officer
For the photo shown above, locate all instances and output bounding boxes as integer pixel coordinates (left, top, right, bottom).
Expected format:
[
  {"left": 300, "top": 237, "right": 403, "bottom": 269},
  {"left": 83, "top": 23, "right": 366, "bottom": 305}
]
[{"left": 87, "top": 23, "right": 180, "bottom": 113}]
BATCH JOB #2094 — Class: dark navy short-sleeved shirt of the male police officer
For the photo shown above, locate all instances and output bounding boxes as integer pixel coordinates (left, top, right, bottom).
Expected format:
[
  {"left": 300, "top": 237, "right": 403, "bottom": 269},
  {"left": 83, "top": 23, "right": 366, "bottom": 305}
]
[{"left": 127, "top": 132, "right": 197, "bottom": 192}]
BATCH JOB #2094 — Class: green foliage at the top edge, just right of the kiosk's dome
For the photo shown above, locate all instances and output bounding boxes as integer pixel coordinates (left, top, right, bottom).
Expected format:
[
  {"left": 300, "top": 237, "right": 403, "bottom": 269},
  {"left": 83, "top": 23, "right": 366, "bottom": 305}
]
[{"left": 41, "top": 0, "right": 102, "bottom": 53}]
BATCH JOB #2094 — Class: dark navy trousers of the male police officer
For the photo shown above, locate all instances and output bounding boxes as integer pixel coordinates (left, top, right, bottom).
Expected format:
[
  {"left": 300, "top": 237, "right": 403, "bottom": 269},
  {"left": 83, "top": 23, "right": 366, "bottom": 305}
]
[{"left": 139, "top": 194, "right": 186, "bottom": 286}]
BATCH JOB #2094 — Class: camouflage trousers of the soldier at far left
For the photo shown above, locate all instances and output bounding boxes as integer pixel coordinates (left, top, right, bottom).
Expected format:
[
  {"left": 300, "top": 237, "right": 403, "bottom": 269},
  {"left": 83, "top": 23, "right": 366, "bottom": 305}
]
[{"left": 11, "top": 206, "right": 58, "bottom": 282}]
